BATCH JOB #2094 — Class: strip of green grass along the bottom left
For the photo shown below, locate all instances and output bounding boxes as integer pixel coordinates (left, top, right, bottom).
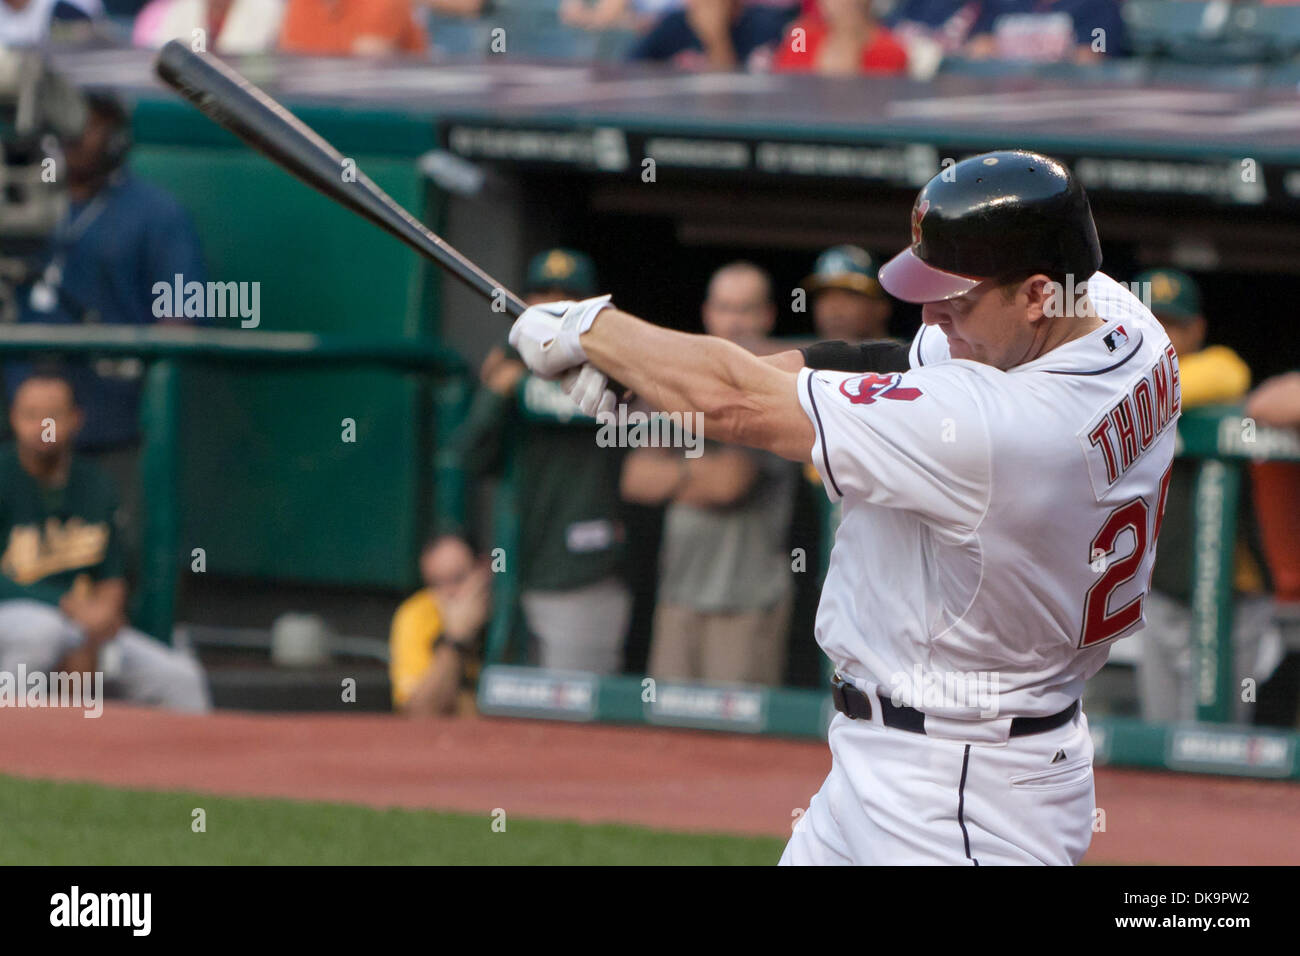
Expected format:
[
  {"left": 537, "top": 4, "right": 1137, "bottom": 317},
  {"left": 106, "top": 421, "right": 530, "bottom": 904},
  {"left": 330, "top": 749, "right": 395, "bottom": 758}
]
[{"left": 0, "top": 777, "right": 784, "bottom": 865}]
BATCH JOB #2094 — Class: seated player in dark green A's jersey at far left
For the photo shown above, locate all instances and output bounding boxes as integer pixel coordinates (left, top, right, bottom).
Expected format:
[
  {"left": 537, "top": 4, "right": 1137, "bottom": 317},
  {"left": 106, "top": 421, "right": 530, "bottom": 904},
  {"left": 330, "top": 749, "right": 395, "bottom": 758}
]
[{"left": 0, "top": 369, "right": 211, "bottom": 711}]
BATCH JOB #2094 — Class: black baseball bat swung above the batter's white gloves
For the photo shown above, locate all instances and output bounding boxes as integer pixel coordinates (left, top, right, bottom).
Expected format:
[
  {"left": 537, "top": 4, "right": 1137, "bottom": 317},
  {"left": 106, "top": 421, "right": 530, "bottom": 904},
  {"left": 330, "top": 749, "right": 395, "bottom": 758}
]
[{"left": 155, "top": 40, "right": 525, "bottom": 316}]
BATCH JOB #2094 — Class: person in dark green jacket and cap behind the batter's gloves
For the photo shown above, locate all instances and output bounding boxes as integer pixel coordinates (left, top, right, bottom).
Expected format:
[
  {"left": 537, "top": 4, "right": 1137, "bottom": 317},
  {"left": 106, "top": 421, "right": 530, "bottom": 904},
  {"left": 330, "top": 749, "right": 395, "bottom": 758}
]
[{"left": 454, "top": 248, "right": 632, "bottom": 674}]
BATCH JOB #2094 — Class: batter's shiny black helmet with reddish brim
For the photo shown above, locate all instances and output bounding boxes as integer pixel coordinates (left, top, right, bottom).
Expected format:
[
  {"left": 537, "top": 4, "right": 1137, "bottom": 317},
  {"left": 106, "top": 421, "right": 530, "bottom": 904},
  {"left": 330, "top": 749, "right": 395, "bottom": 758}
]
[{"left": 880, "top": 150, "right": 1101, "bottom": 302}]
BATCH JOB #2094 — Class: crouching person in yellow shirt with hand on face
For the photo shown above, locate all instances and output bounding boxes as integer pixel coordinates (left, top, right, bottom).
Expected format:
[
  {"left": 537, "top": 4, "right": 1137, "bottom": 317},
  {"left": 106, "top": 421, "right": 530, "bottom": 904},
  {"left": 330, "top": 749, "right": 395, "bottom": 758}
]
[{"left": 389, "top": 535, "right": 491, "bottom": 717}]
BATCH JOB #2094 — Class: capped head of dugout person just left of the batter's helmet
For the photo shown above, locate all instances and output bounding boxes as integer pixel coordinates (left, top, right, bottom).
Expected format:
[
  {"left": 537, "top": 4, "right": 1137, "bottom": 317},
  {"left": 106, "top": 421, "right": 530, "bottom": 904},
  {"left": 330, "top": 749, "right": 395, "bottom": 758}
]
[{"left": 803, "top": 246, "right": 893, "bottom": 343}]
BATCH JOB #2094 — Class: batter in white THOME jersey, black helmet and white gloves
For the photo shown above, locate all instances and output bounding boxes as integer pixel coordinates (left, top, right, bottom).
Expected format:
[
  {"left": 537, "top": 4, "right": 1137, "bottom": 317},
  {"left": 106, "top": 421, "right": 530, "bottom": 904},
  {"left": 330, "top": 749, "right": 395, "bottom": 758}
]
[{"left": 511, "top": 151, "right": 1180, "bottom": 865}]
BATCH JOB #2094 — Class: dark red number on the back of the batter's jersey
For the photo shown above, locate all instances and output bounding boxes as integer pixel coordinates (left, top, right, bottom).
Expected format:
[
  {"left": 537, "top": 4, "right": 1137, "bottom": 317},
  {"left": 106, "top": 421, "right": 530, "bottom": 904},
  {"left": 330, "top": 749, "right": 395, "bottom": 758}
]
[{"left": 1079, "top": 464, "right": 1174, "bottom": 648}]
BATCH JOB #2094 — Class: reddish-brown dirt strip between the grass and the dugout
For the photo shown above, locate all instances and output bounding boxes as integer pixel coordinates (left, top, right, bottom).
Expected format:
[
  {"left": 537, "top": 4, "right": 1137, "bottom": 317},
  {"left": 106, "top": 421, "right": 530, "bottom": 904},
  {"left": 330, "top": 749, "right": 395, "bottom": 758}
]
[{"left": 0, "top": 705, "right": 1300, "bottom": 864}]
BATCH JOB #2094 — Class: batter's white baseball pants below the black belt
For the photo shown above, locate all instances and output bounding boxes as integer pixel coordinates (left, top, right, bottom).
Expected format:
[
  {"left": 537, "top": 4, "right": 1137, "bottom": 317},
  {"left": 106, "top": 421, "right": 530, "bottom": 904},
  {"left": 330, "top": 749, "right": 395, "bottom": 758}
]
[{"left": 781, "top": 708, "right": 1095, "bottom": 866}]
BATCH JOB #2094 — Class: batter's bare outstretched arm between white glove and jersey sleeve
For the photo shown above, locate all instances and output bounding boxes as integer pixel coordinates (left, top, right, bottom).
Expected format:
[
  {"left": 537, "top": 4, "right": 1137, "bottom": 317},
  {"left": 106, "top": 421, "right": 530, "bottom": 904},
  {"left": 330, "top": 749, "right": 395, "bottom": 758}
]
[{"left": 581, "top": 308, "right": 790, "bottom": 447}]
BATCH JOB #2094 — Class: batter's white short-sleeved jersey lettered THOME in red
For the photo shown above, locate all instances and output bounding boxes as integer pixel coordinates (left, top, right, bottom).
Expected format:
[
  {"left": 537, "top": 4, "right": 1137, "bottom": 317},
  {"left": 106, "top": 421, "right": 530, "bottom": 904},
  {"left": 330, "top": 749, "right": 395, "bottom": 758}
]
[{"left": 798, "top": 272, "right": 1180, "bottom": 723}]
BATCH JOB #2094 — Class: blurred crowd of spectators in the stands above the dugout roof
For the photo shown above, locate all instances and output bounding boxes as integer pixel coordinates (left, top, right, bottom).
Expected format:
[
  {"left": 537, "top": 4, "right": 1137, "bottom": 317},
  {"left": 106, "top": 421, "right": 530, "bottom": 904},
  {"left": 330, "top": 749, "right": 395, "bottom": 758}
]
[{"left": 10, "top": 0, "right": 1300, "bottom": 79}]
